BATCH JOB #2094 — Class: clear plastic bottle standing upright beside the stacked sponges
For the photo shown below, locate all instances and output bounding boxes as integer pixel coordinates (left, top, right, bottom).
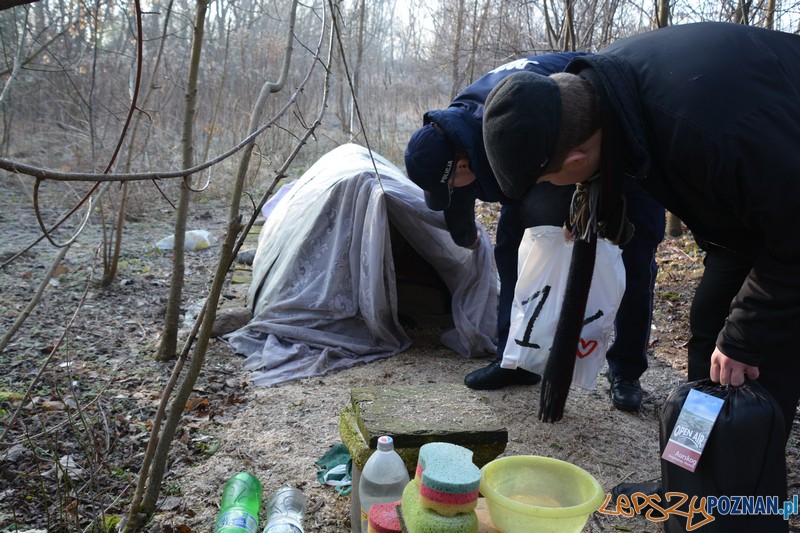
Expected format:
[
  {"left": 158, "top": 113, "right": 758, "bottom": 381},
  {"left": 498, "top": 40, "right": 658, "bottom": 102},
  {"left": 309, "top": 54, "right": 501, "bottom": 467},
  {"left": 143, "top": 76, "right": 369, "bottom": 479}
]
[{"left": 358, "top": 436, "right": 409, "bottom": 533}]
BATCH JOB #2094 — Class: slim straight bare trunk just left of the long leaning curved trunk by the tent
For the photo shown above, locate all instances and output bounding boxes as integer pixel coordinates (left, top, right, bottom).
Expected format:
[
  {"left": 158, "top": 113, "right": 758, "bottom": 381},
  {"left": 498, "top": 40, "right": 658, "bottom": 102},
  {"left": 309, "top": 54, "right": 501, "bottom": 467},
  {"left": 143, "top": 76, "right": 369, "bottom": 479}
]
[{"left": 156, "top": 0, "right": 209, "bottom": 361}]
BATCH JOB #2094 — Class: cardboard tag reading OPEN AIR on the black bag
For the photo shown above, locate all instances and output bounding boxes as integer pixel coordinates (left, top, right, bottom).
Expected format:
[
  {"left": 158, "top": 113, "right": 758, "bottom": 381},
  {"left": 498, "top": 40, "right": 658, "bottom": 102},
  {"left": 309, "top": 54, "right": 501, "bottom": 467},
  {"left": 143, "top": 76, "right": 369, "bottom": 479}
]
[{"left": 661, "top": 389, "right": 725, "bottom": 472}]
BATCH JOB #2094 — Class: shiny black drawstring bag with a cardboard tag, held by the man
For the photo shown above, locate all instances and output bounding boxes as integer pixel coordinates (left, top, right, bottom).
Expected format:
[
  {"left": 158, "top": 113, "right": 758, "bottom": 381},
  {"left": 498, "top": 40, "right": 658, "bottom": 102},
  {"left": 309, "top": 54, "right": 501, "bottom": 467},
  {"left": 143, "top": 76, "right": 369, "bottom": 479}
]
[{"left": 659, "top": 379, "right": 789, "bottom": 533}]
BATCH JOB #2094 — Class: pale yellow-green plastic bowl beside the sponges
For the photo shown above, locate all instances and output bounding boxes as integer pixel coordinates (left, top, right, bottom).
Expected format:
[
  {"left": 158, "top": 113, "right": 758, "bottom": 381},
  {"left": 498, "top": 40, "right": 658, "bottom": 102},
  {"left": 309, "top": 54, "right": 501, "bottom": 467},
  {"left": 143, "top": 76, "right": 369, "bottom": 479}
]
[{"left": 480, "top": 455, "right": 605, "bottom": 533}]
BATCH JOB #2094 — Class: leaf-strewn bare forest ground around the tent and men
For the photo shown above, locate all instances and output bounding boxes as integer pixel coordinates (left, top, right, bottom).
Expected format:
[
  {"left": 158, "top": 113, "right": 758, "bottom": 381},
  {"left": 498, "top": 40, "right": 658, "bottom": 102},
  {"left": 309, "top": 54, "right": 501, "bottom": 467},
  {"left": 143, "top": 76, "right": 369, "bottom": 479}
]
[{"left": 0, "top": 178, "right": 800, "bottom": 533}]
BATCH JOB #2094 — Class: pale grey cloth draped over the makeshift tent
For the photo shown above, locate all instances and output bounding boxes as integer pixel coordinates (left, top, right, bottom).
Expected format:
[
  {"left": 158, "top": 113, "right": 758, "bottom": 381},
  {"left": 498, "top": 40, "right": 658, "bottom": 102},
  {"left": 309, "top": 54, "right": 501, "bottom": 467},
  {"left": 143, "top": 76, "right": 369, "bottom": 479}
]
[{"left": 227, "top": 144, "right": 497, "bottom": 386}]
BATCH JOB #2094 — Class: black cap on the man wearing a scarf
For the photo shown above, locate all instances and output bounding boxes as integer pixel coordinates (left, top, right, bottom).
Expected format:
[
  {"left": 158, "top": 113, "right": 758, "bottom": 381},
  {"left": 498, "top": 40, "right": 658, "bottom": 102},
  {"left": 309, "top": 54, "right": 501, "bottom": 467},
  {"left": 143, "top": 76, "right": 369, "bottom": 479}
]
[{"left": 483, "top": 72, "right": 561, "bottom": 198}]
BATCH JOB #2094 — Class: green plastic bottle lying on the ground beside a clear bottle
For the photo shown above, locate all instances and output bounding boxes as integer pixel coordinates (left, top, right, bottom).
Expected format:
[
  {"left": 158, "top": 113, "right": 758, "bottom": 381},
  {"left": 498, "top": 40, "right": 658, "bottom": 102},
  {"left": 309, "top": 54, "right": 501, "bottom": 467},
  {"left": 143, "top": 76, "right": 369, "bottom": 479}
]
[{"left": 214, "top": 472, "right": 262, "bottom": 533}]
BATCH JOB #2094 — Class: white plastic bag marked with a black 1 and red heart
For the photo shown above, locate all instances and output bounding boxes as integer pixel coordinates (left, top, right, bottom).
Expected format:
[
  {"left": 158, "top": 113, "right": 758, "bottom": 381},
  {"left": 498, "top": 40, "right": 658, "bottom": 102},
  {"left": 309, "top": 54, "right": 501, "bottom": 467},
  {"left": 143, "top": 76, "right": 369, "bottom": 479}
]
[{"left": 501, "top": 226, "right": 625, "bottom": 390}]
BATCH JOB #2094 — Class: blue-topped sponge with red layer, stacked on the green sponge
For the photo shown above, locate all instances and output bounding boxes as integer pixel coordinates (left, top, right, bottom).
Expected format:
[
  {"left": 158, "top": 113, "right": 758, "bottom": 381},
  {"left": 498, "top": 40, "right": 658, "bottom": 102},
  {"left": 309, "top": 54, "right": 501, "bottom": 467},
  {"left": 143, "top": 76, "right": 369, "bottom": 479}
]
[{"left": 414, "top": 442, "right": 481, "bottom": 516}]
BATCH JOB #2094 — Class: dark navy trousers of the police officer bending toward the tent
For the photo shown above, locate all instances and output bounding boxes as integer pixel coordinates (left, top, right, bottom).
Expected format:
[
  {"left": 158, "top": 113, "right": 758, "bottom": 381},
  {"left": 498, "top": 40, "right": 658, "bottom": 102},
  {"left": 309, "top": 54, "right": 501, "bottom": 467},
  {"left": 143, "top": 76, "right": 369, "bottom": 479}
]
[{"left": 494, "top": 179, "right": 666, "bottom": 379}]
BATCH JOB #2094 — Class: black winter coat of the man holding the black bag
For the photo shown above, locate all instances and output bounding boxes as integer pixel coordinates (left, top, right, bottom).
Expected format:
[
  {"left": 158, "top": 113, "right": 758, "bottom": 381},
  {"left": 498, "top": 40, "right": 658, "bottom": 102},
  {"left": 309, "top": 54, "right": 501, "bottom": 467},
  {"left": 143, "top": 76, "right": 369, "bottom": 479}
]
[{"left": 567, "top": 23, "right": 800, "bottom": 365}]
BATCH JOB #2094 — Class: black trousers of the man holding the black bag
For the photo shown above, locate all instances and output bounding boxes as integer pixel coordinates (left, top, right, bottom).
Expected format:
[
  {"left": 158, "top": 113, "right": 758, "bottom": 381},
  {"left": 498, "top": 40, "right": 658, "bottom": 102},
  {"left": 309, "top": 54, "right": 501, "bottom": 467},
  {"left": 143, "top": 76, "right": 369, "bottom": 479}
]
[{"left": 687, "top": 244, "right": 800, "bottom": 439}]
